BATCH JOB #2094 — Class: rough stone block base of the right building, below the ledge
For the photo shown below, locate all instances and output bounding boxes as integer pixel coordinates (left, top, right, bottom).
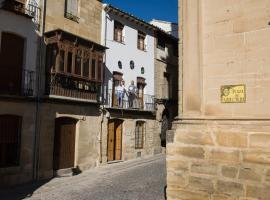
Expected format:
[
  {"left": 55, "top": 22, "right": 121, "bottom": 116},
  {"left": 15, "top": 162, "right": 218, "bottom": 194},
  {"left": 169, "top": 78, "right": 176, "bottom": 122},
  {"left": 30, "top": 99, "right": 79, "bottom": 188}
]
[{"left": 167, "top": 121, "right": 270, "bottom": 200}]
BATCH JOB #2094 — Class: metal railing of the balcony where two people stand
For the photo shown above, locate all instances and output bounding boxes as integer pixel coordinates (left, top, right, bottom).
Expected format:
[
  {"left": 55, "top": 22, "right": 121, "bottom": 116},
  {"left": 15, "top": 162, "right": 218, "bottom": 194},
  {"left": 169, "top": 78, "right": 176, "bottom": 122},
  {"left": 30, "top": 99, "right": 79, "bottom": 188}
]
[{"left": 103, "top": 90, "right": 156, "bottom": 112}]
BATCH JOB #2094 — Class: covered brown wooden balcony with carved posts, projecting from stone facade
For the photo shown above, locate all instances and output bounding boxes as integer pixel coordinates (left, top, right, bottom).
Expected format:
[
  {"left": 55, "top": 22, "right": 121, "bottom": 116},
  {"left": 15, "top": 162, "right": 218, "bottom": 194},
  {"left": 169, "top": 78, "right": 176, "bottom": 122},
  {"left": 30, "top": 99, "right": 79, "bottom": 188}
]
[{"left": 45, "top": 29, "right": 105, "bottom": 102}]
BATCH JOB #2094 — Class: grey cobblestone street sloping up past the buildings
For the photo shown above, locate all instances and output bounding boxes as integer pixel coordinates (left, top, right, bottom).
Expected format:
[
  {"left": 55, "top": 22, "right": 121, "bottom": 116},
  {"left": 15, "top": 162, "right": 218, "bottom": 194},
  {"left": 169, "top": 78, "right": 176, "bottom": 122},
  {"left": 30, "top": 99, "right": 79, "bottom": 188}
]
[{"left": 0, "top": 155, "right": 166, "bottom": 200}]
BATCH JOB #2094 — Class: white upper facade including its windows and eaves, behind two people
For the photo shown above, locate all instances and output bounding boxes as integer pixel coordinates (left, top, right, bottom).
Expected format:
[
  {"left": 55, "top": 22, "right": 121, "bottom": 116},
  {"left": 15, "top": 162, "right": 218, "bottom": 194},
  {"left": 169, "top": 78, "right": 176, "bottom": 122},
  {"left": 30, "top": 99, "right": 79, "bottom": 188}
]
[{"left": 102, "top": 4, "right": 155, "bottom": 109}]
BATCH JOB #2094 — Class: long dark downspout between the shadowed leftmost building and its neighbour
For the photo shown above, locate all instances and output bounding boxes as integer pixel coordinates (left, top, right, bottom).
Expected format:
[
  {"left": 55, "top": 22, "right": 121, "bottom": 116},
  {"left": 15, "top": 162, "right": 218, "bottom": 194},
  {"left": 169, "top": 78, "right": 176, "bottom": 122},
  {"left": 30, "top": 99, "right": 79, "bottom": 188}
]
[{"left": 32, "top": 0, "right": 47, "bottom": 181}]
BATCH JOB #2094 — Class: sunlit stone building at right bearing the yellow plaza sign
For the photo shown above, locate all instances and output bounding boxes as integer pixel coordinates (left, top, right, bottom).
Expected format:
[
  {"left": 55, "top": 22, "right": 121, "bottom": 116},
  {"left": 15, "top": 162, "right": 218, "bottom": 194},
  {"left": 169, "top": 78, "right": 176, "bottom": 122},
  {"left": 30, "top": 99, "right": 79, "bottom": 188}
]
[{"left": 167, "top": 0, "right": 270, "bottom": 200}]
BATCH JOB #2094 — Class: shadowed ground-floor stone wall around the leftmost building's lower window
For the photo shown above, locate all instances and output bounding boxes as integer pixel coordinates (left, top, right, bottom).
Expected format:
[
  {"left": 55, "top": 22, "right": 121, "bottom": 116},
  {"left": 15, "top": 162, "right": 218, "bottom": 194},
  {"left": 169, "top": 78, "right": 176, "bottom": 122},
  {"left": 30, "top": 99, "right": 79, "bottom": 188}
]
[{"left": 0, "top": 100, "right": 35, "bottom": 186}]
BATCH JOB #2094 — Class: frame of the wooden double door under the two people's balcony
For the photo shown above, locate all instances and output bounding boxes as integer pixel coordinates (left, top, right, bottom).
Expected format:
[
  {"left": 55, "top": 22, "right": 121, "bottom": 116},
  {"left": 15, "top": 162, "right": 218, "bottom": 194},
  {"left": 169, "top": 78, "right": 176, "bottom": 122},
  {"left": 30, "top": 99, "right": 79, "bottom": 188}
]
[{"left": 107, "top": 118, "right": 124, "bottom": 162}]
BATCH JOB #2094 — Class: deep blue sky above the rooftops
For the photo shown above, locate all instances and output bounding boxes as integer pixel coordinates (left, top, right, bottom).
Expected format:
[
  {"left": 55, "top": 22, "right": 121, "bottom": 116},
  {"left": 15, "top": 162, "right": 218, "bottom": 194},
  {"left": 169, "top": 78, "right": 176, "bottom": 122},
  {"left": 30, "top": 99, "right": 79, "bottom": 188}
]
[{"left": 103, "top": 0, "right": 178, "bottom": 22}]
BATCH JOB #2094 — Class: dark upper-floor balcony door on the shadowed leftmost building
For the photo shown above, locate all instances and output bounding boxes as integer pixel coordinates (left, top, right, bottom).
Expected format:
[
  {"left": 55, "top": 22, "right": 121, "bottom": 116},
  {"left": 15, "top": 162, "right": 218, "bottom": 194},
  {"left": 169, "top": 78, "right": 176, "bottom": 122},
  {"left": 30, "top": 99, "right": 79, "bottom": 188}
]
[{"left": 0, "top": 32, "right": 24, "bottom": 95}]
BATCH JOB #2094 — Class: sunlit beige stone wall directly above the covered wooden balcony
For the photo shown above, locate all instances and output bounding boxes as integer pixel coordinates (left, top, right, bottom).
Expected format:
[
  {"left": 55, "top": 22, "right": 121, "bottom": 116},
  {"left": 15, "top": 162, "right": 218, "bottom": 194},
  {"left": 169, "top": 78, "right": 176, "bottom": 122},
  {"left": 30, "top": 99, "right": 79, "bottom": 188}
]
[{"left": 45, "top": 0, "right": 102, "bottom": 44}]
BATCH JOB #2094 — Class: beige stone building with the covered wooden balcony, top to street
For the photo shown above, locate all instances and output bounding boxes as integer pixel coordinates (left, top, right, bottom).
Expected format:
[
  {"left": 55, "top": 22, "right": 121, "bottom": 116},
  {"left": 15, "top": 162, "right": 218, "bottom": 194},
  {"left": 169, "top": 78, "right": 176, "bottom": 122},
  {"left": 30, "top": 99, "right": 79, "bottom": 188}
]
[{"left": 36, "top": 0, "right": 106, "bottom": 179}]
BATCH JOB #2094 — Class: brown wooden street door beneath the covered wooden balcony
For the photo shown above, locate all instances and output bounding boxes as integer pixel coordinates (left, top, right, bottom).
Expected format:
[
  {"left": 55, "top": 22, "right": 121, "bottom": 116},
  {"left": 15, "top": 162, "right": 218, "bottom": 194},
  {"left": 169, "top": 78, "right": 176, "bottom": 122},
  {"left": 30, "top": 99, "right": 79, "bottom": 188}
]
[{"left": 54, "top": 118, "right": 77, "bottom": 170}]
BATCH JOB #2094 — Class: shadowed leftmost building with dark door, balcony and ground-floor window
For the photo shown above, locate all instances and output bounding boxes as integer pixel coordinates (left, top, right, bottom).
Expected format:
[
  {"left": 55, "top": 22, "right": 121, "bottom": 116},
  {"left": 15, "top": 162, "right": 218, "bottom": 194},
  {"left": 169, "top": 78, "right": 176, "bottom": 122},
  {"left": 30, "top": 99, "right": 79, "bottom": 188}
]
[{"left": 0, "top": 0, "right": 39, "bottom": 186}]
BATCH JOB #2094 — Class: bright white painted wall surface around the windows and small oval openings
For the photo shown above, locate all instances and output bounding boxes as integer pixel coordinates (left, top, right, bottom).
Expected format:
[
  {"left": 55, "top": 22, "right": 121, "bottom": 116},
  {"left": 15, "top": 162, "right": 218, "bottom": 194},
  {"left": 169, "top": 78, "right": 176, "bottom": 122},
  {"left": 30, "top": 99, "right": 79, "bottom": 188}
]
[{"left": 101, "top": 7, "right": 155, "bottom": 95}]
